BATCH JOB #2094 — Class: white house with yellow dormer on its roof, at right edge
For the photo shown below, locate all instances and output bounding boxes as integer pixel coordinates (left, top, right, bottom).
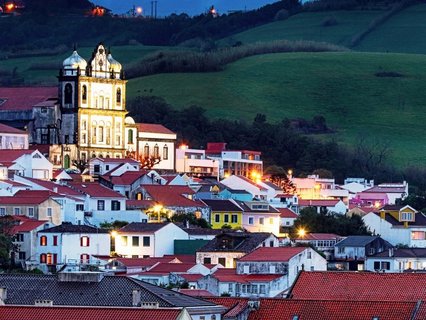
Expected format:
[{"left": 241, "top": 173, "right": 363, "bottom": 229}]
[{"left": 362, "top": 205, "right": 426, "bottom": 248}]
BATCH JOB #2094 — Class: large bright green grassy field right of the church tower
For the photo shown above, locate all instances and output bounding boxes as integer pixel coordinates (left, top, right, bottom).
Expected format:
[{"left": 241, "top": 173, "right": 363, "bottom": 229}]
[{"left": 128, "top": 53, "right": 426, "bottom": 166}]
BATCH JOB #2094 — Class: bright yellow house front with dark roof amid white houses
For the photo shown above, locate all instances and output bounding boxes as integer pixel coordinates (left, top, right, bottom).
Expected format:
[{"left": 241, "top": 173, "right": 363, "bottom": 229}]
[{"left": 202, "top": 200, "right": 243, "bottom": 229}]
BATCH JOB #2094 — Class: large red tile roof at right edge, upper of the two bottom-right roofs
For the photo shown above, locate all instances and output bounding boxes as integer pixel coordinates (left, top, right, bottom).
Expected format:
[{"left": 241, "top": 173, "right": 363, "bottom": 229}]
[{"left": 290, "top": 271, "right": 426, "bottom": 301}]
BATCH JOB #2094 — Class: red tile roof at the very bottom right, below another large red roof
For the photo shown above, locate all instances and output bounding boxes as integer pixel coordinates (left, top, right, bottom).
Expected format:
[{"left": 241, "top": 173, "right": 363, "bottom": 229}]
[{"left": 248, "top": 299, "right": 416, "bottom": 320}]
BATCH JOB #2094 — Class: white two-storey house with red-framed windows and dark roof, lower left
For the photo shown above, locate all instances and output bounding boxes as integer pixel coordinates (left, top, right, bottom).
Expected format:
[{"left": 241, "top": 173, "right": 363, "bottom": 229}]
[{"left": 37, "top": 222, "right": 111, "bottom": 271}]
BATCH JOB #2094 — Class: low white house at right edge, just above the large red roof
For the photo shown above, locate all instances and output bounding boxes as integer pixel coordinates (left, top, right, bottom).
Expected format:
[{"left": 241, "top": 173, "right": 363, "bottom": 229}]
[{"left": 365, "top": 248, "right": 426, "bottom": 272}]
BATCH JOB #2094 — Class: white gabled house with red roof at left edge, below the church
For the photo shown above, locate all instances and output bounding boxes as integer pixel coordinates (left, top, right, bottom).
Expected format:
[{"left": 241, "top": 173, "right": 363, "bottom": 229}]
[{"left": 0, "top": 150, "right": 53, "bottom": 180}]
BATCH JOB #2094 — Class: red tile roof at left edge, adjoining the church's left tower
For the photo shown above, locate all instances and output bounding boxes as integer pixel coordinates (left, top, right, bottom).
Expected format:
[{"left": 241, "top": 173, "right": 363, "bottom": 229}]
[{"left": 0, "top": 87, "right": 58, "bottom": 111}]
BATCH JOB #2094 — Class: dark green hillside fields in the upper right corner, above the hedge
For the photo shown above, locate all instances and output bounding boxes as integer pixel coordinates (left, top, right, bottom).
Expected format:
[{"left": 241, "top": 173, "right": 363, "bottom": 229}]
[{"left": 221, "top": 4, "right": 426, "bottom": 53}]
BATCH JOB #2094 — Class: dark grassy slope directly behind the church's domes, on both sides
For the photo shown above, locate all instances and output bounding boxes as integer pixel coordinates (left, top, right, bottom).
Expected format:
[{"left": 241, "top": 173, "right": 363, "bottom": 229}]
[{"left": 0, "top": 44, "right": 168, "bottom": 85}]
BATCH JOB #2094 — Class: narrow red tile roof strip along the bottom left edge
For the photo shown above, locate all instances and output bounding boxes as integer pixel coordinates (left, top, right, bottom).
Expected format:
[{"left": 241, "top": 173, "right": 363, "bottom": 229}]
[{"left": 0, "top": 305, "right": 182, "bottom": 320}]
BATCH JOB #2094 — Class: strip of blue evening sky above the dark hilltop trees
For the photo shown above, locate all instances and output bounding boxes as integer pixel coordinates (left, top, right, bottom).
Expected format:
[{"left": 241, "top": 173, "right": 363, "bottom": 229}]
[{"left": 92, "top": 0, "right": 277, "bottom": 17}]
